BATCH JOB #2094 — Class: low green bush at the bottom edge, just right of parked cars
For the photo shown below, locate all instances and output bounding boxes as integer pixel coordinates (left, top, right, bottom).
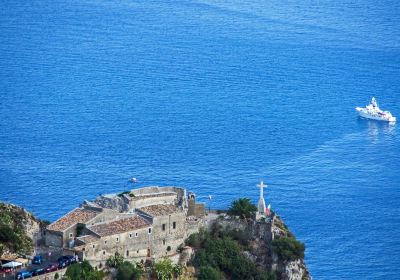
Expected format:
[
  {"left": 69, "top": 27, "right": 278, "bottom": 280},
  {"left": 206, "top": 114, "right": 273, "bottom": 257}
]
[{"left": 63, "top": 261, "right": 106, "bottom": 280}]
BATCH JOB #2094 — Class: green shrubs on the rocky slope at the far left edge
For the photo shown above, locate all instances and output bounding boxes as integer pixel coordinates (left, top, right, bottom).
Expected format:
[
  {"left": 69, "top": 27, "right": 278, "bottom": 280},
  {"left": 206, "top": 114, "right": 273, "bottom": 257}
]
[{"left": 0, "top": 203, "right": 35, "bottom": 255}]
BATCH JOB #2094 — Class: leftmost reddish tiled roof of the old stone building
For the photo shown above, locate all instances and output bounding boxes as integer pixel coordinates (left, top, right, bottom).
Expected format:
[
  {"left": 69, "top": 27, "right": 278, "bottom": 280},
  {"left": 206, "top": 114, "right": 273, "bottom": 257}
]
[{"left": 47, "top": 208, "right": 99, "bottom": 231}]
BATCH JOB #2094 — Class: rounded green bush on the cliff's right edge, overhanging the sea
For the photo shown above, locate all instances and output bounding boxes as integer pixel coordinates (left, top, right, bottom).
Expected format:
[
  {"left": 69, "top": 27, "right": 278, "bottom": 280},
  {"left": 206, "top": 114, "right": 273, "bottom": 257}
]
[{"left": 272, "top": 237, "right": 305, "bottom": 261}]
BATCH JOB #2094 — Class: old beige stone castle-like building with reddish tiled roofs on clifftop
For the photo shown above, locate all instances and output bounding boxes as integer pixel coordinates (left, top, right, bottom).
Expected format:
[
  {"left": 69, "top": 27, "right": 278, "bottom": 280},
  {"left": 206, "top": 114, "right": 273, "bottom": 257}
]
[{"left": 45, "top": 187, "right": 205, "bottom": 265}]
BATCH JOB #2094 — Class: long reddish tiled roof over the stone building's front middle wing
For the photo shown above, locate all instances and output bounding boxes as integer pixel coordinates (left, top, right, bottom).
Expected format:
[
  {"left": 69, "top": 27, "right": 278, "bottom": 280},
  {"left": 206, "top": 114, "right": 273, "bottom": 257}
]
[{"left": 89, "top": 215, "right": 150, "bottom": 236}]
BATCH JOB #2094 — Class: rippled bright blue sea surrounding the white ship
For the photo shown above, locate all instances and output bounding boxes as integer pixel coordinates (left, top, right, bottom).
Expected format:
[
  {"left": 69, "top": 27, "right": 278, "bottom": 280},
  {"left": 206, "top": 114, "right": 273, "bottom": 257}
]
[{"left": 0, "top": 0, "right": 400, "bottom": 279}]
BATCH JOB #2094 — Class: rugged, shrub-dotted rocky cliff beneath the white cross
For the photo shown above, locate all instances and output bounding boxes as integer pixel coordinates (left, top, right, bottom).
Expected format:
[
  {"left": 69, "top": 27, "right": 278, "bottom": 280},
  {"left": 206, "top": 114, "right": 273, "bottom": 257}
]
[{"left": 188, "top": 212, "right": 311, "bottom": 280}]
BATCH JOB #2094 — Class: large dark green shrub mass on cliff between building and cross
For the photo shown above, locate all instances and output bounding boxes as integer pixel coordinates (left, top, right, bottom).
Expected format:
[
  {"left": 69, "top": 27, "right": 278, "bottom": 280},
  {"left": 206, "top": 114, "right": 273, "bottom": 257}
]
[{"left": 186, "top": 226, "right": 275, "bottom": 280}]
